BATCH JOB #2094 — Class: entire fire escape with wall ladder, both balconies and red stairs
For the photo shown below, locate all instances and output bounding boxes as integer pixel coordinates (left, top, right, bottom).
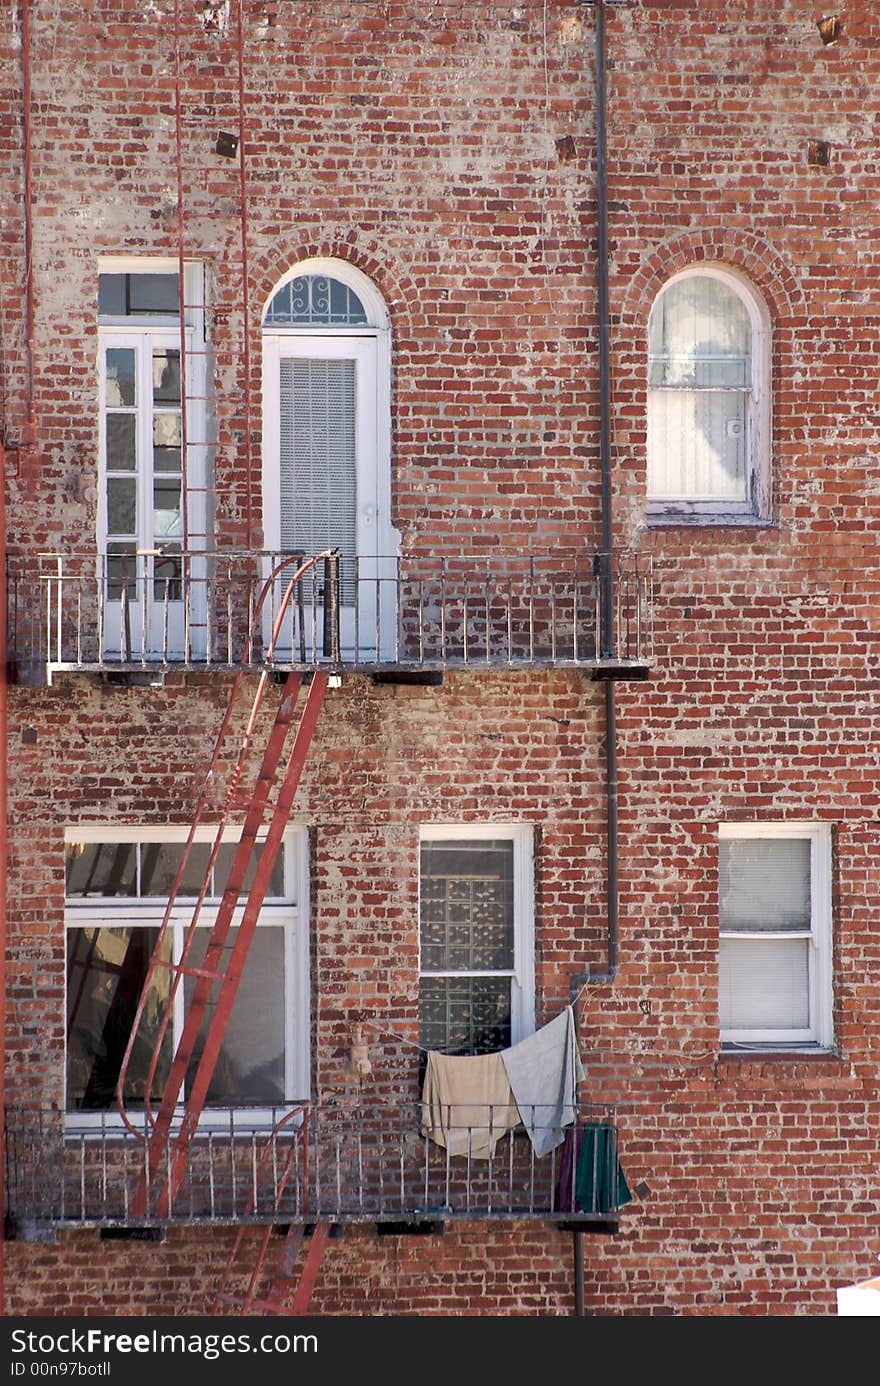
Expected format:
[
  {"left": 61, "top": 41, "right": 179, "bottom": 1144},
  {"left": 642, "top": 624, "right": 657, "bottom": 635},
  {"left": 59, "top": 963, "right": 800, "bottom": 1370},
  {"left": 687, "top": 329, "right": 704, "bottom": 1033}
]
[{"left": 7, "top": 0, "right": 651, "bottom": 1314}]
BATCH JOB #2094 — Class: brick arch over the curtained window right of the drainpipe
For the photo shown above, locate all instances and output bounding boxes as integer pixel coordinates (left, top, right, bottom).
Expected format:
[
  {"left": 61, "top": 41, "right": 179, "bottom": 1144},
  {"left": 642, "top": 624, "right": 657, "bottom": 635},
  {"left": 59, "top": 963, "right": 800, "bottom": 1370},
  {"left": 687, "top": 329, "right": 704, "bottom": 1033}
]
[{"left": 619, "top": 226, "right": 805, "bottom": 331}]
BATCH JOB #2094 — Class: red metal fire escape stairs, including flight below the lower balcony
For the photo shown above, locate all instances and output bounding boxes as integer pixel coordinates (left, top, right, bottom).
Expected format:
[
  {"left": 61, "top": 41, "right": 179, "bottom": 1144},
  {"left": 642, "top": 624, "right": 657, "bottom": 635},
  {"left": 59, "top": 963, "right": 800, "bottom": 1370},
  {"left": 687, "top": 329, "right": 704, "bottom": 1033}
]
[{"left": 116, "top": 559, "right": 336, "bottom": 1314}]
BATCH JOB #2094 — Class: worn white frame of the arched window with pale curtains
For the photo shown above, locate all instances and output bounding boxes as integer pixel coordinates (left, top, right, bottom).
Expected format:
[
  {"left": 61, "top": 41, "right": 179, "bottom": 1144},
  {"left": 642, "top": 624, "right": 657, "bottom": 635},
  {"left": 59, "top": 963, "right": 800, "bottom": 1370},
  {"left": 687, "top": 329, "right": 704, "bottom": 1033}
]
[{"left": 646, "top": 263, "right": 772, "bottom": 524}]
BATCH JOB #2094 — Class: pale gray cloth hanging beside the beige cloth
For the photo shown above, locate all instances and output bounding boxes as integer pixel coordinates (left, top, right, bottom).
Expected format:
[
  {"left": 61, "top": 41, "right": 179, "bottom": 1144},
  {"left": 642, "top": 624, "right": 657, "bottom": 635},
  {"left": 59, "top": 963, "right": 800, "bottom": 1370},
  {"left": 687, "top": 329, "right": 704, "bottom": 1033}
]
[{"left": 502, "top": 1006, "right": 583, "bottom": 1156}]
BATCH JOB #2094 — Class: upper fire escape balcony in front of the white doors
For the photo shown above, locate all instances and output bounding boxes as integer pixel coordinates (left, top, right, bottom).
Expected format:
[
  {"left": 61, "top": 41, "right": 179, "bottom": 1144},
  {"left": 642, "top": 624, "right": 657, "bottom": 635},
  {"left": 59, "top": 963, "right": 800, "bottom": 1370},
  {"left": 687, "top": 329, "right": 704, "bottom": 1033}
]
[{"left": 7, "top": 549, "right": 653, "bottom": 683}]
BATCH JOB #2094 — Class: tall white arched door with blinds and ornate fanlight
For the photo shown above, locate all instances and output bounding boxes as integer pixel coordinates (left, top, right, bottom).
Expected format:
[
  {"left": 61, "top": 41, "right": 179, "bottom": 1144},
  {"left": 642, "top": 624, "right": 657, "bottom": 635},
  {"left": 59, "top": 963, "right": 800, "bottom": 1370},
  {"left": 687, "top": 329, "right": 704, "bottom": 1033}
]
[{"left": 263, "top": 259, "right": 398, "bottom": 661}]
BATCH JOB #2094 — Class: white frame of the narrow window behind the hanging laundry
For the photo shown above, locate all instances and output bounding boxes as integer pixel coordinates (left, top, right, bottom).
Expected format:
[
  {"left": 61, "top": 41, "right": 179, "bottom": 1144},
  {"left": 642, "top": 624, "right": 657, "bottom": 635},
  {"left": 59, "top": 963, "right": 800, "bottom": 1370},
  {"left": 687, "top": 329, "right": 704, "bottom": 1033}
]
[{"left": 419, "top": 823, "right": 535, "bottom": 1045}]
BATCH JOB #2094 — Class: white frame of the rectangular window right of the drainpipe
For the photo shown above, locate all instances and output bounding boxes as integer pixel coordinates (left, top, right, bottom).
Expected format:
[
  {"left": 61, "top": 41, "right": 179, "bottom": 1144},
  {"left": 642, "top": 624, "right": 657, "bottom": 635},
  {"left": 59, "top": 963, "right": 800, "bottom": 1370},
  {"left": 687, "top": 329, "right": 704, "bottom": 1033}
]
[{"left": 718, "top": 822, "right": 833, "bottom": 1049}]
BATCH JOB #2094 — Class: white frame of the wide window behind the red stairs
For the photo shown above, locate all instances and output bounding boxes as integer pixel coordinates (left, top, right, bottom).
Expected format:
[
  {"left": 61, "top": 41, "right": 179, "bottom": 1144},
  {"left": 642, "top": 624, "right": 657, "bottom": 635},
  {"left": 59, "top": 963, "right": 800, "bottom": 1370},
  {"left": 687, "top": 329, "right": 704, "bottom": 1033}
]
[{"left": 64, "top": 823, "right": 310, "bottom": 1131}]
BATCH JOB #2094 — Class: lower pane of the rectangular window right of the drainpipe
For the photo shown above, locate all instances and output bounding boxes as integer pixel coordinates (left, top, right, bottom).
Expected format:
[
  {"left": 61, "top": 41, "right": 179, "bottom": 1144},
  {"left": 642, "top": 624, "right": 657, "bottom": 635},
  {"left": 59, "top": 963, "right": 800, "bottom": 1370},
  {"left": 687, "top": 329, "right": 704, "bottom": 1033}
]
[{"left": 718, "top": 938, "right": 811, "bottom": 1030}]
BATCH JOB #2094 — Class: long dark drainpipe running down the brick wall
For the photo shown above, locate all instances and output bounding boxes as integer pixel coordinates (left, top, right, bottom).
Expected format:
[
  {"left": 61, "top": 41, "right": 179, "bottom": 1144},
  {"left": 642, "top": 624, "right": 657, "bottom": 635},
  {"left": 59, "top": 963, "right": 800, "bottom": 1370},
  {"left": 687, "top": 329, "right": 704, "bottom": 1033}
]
[{"left": 571, "top": 0, "right": 618, "bottom": 1318}]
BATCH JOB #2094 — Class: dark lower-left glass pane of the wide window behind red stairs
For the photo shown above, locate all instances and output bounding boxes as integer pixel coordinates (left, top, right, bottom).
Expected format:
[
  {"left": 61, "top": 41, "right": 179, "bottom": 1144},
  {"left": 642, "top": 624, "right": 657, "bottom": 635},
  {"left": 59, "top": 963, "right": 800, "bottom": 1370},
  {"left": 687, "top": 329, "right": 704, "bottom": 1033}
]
[{"left": 67, "top": 927, "right": 172, "bottom": 1112}]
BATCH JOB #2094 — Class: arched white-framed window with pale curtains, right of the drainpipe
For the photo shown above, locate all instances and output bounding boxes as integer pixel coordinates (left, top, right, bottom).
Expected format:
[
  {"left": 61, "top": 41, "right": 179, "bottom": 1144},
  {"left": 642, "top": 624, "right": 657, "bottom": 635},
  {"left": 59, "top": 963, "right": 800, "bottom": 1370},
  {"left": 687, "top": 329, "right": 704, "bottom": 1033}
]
[{"left": 647, "top": 266, "right": 771, "bottom": 521}]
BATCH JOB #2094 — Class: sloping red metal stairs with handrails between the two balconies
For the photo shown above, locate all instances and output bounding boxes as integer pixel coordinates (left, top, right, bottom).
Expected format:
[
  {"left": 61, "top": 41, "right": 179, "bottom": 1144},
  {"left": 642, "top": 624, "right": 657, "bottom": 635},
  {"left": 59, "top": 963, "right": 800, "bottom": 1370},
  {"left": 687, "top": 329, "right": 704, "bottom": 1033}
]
[{"left": 116, "top": 550, "right": 338, "bottom": 1217}]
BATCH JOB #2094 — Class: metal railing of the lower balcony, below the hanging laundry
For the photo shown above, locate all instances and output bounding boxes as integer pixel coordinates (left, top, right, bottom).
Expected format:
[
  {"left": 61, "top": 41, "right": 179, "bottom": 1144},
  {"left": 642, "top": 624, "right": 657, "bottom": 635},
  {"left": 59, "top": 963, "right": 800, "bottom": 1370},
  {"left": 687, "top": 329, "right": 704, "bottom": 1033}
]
[{"left": 6, "top": 1102, "right": 619, "bottom": 1236}]
